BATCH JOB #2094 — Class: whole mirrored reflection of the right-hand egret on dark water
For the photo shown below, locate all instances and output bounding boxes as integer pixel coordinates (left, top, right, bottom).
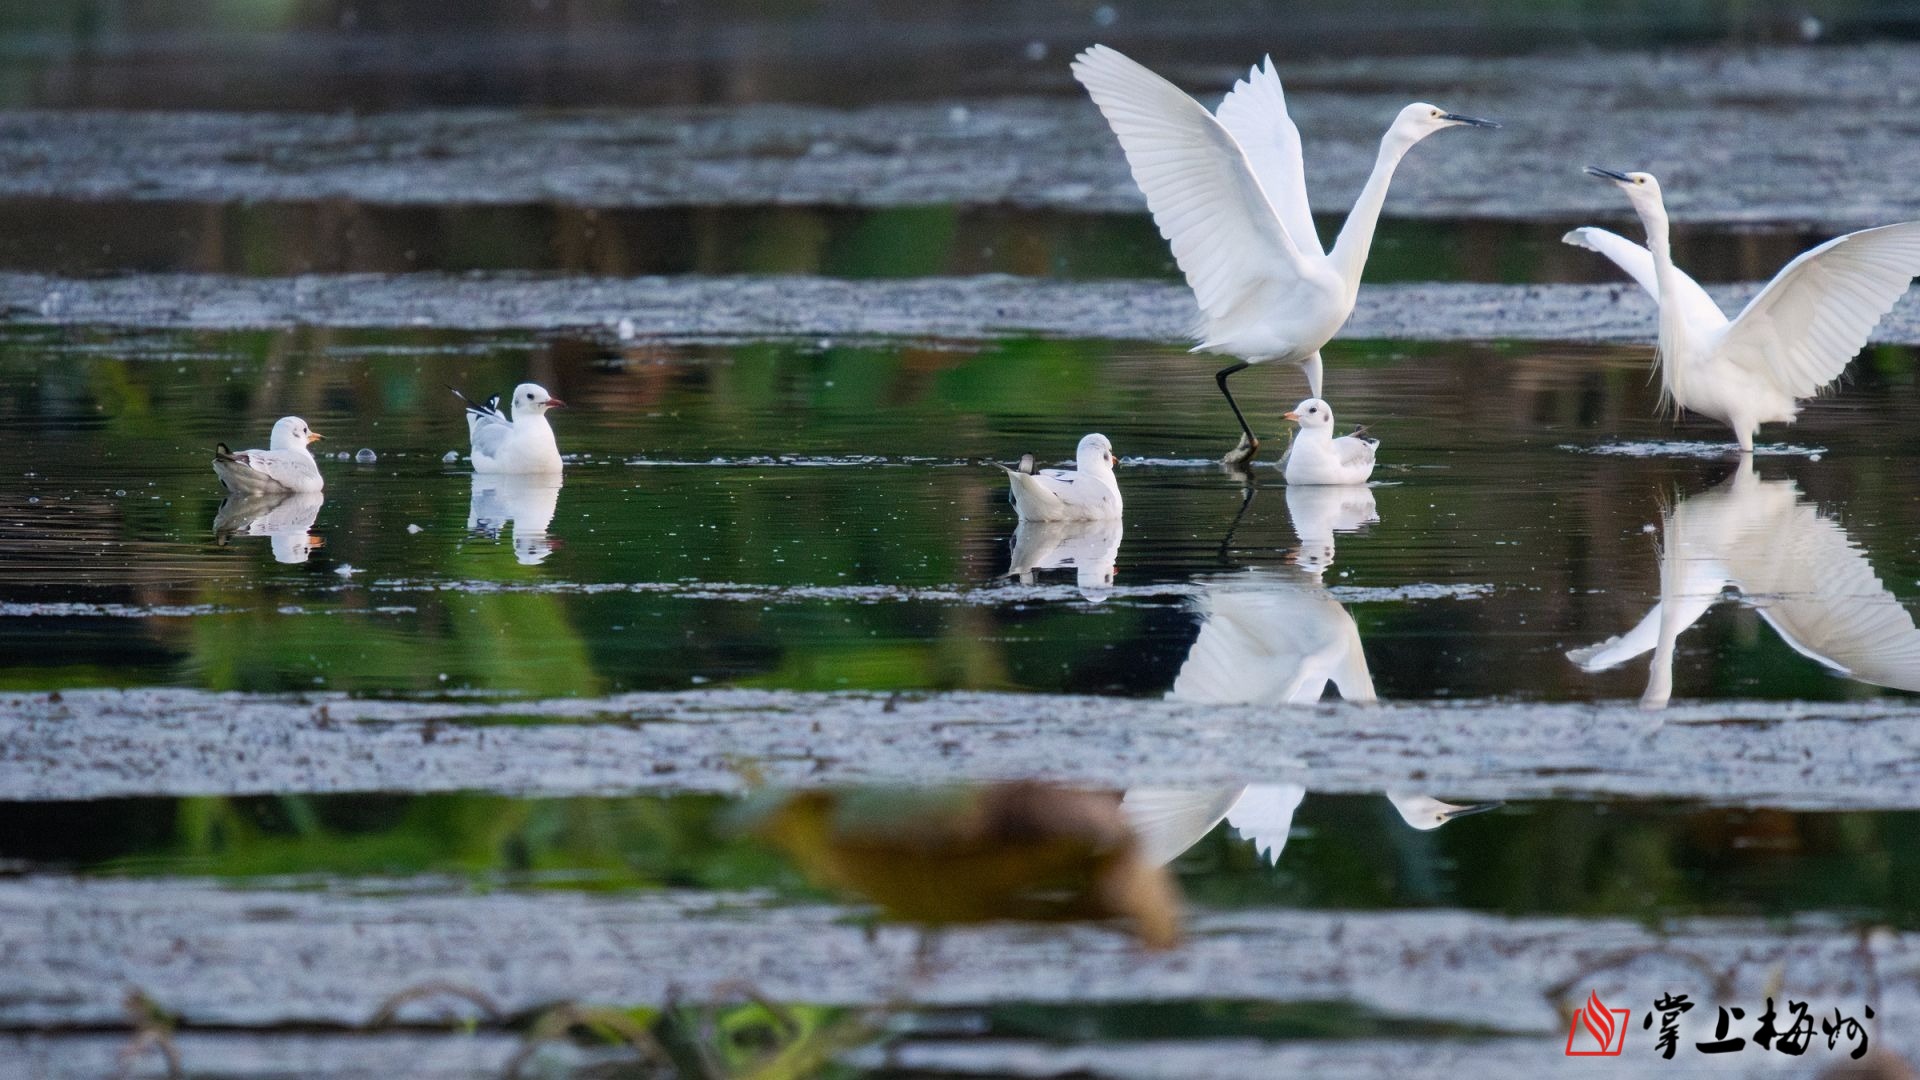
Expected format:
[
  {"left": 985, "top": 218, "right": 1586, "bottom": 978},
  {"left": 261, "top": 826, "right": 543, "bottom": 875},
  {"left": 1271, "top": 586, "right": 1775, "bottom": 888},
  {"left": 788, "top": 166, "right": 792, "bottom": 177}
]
[{"left": 1567, "top": 457, "right": 1920, "bottom": 709}]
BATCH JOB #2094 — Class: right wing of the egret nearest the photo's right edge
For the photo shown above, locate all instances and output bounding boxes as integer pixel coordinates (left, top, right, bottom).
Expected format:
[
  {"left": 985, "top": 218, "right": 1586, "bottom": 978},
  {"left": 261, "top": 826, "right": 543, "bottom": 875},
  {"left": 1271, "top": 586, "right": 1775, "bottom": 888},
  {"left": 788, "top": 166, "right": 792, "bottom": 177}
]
[{"left": 1722, "top": 221, "right": 1920, "bottom": 398}]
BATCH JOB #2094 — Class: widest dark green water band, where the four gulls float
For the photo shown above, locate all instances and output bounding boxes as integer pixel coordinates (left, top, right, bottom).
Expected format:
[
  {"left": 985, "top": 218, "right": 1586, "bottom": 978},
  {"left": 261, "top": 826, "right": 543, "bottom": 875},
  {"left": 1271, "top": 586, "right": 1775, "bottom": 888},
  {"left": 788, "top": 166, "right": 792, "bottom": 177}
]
[{"left": 0, "top": 322, "right": 1920, "bottom": 700}]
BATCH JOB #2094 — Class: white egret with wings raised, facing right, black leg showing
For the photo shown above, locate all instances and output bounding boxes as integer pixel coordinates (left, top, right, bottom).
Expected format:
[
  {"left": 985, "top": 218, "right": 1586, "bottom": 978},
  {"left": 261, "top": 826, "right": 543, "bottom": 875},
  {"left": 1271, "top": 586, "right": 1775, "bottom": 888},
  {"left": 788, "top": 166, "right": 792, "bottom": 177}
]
[{"left": 1073, "top": 44, "right": 1500, "bottom": 465}]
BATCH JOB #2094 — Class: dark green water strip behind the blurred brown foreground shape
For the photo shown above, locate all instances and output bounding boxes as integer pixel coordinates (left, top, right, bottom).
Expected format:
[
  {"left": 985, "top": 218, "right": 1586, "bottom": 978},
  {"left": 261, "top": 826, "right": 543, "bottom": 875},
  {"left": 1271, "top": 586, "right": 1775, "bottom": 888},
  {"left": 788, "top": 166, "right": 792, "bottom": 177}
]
[{"left": 0, "top": 794, "right": 1920, "bottom": 926}]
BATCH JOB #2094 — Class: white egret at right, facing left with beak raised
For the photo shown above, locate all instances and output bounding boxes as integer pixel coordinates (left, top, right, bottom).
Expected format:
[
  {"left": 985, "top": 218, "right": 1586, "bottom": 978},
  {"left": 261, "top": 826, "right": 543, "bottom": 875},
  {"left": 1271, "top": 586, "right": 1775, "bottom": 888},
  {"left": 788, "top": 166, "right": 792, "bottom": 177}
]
[{"left": 1563, "top": 165, "right": 1920, "bottom": 454}]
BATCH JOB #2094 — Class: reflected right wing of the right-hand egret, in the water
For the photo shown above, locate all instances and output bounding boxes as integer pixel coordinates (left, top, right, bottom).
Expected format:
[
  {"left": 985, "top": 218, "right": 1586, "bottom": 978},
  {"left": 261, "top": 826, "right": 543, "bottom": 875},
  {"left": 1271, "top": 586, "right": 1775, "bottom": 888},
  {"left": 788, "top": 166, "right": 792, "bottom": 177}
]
[{"left": 1728, "top": 490, "right": 1920, "bottom": 690}]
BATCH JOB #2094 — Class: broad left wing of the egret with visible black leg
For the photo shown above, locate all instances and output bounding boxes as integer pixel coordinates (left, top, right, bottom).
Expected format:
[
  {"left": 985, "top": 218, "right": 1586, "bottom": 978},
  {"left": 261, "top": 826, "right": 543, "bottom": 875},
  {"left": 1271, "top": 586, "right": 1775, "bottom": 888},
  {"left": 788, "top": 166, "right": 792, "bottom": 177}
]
[{"left": 1073, "top": 44, "right": 1300, "bottom": 319}]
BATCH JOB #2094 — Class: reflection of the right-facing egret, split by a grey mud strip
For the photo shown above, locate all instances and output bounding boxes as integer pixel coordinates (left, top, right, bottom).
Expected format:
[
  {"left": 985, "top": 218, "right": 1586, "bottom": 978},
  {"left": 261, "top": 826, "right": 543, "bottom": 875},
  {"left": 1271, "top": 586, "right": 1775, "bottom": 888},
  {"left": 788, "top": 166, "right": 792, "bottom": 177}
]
[{"left": 1121, "top": 572, "right": 1500, "bottom": 863}]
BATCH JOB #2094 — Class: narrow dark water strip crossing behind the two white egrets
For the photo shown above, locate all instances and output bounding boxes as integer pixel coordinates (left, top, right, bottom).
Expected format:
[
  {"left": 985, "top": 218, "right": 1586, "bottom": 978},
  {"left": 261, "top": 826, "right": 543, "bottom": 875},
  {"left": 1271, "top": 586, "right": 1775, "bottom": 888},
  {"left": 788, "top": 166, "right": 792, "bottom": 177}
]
[{"left": 0, "top": 198, "right": 1828, "bottom": 284}]
